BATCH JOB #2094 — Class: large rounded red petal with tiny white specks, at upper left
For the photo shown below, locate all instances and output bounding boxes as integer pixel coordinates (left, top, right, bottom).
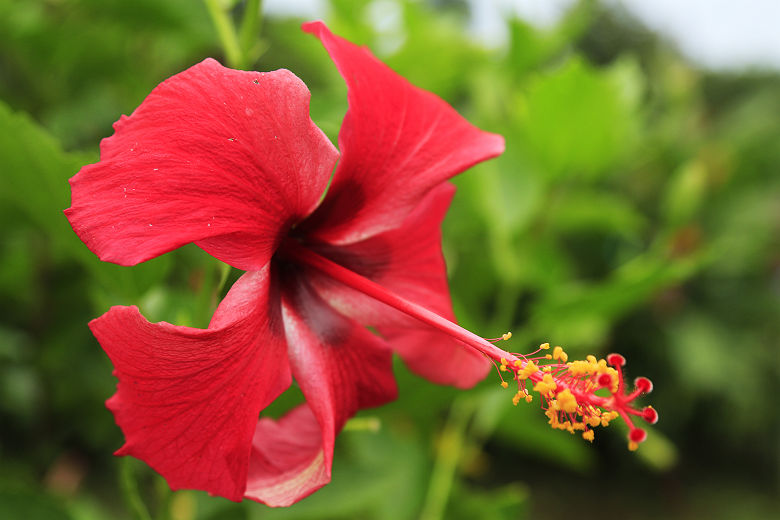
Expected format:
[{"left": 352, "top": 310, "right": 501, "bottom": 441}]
[{"left": 65, "top": 59, "right": 338, "bottom": 270}]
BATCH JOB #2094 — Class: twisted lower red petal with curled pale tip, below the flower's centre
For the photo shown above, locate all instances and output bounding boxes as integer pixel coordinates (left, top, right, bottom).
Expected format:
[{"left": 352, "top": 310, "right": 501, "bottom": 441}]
[{"left": 246, "top": 275, "right": 397, "bottom": 506}]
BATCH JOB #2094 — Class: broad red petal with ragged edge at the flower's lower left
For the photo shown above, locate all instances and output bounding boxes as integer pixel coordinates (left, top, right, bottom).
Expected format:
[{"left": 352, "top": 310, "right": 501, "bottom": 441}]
[{"left": 90, "top": 270, "right": 291, "bottom": 500}]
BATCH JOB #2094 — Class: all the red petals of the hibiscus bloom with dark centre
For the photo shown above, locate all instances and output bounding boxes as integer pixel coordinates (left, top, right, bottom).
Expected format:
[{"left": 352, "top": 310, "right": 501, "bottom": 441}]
[{"left": 66, "top": 22, "right": 504, "bottom": 506}]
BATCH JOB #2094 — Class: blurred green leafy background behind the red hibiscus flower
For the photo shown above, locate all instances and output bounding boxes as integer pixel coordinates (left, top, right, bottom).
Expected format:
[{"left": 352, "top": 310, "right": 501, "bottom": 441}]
[{"left": 0, "top": 0, "right": 780, "bottom": 520}]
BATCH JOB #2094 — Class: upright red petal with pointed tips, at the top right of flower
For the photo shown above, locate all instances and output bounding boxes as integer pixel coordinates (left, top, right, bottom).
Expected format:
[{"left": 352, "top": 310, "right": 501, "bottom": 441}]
[{"left": 303, "top": 22, "right": 504, "bottom": 244}]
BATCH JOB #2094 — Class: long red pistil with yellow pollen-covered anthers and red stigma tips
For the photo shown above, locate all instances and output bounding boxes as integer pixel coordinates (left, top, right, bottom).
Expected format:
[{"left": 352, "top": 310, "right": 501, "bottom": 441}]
[{"left": 282, "top": 240, "right": 658, "bottom": 450}]
